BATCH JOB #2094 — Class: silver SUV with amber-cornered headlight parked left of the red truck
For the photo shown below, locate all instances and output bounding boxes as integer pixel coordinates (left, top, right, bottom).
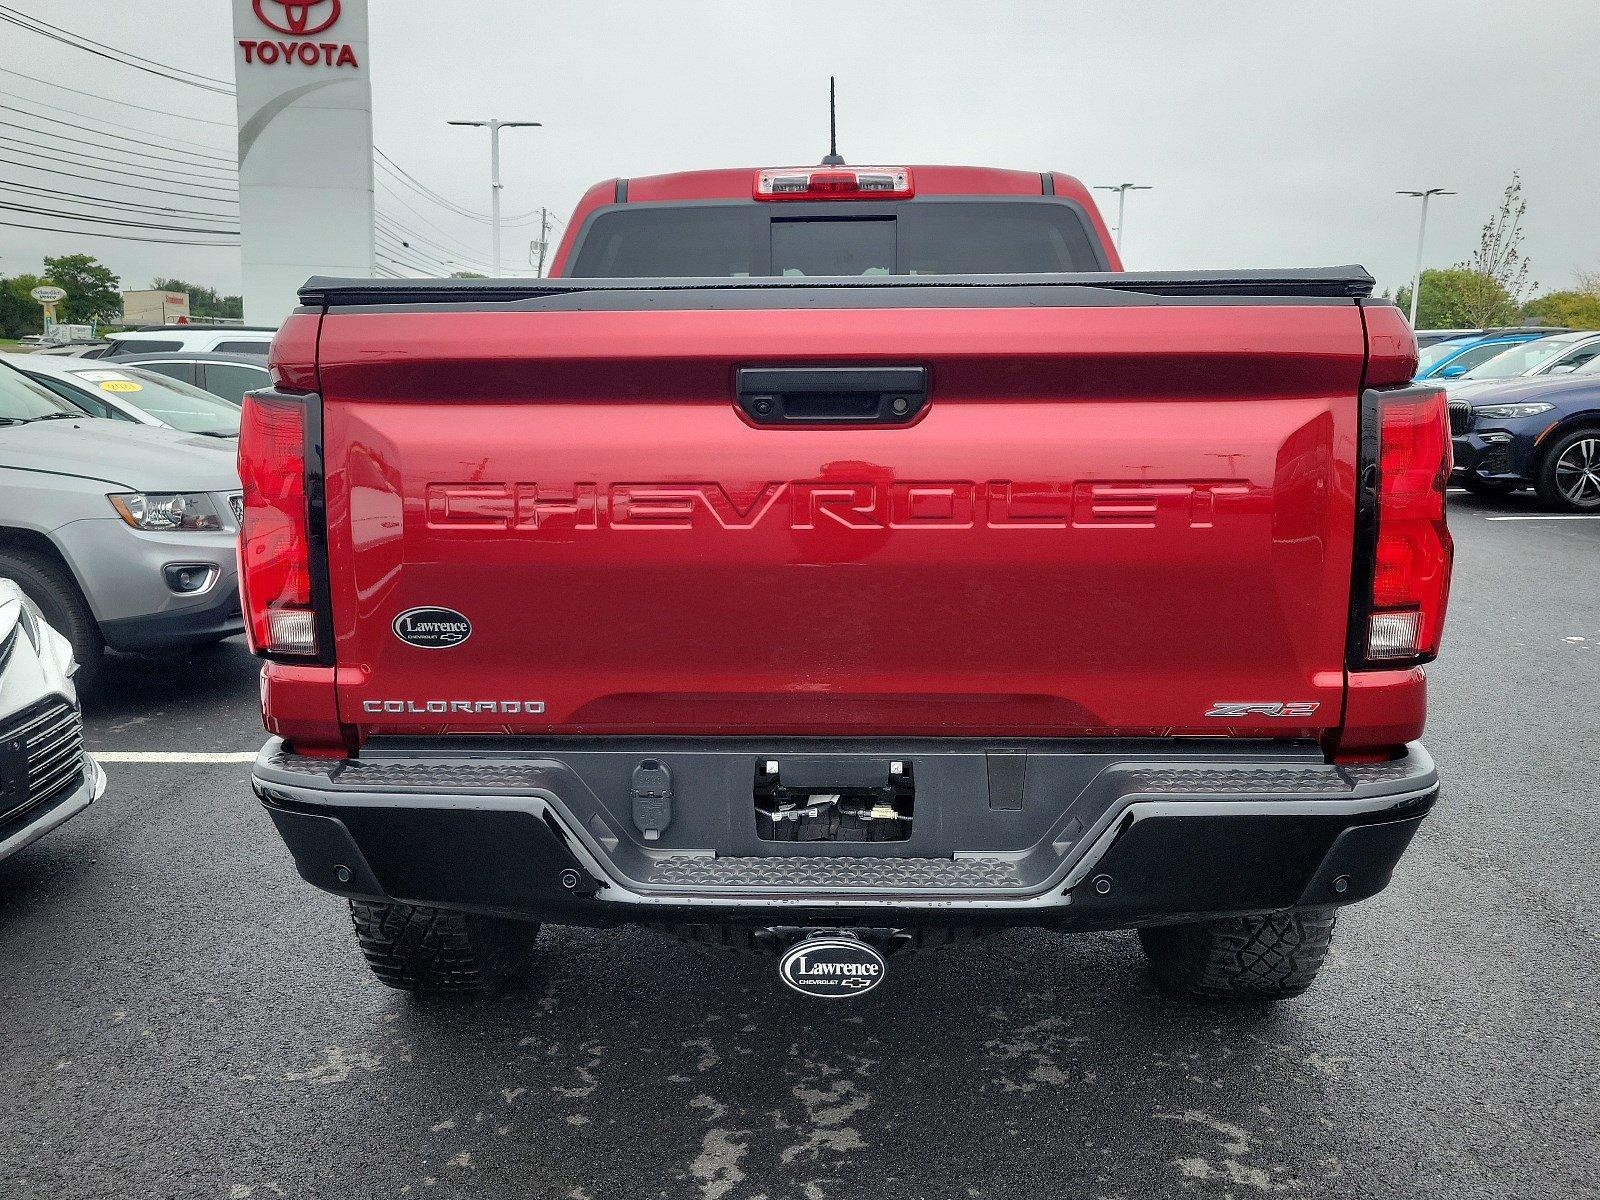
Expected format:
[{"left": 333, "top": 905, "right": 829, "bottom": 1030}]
[{"left": 0, "top": 356, "right": 243, "bottom": 688}]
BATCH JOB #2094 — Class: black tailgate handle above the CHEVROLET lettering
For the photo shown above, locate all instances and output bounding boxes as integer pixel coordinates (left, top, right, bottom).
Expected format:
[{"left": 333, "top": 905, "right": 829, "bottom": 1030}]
[{"left": 736, "top": 366, "right": 928, "bottom": 426}]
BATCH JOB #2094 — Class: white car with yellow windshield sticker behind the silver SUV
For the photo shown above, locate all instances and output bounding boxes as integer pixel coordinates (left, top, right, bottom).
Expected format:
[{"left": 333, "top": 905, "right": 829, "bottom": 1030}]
[{"left": 0, "top": 354, "right": 238, "bottom": 437}]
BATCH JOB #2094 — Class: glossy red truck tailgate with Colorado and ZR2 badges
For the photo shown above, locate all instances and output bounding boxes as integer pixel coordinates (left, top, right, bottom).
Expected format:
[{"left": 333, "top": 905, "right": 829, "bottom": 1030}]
[{"left": 318, "top": 298, "right": 1366, "bottom": 738}]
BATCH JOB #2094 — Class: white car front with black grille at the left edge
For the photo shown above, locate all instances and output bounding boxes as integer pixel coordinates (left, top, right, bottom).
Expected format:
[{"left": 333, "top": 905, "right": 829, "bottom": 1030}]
[{"left": 0, "top": 579, "right": 106, "bottom": 859}]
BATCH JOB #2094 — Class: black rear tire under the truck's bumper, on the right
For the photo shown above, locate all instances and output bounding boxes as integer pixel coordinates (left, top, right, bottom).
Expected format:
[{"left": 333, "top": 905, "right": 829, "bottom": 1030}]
[{"left": 1139, "top": 909, "right": 1334, "bottom": 1000}]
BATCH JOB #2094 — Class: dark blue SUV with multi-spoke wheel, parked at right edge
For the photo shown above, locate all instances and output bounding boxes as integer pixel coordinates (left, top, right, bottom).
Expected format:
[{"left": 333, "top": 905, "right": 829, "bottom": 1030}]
[{"left": 1450, "top": 358, "right": 1600, "bottom": 512}]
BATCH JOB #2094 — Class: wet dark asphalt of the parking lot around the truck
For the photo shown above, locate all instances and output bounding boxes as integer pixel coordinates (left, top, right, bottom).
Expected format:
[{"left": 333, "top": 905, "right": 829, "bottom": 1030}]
[{"left": 0, "top": 496, "right": 1600, "bottom": 1200}]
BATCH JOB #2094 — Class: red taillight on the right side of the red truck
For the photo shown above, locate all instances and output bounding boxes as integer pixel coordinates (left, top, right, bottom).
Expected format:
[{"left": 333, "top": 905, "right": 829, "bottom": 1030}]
[{"left": 1363, "top": 389, "right": 1454, "bottom": 666}]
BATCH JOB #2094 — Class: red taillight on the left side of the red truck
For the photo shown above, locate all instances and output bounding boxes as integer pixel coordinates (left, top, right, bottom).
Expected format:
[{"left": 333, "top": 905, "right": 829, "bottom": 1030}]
[{"left": 238, "top": 392, "right": 317, "bottom": 656}]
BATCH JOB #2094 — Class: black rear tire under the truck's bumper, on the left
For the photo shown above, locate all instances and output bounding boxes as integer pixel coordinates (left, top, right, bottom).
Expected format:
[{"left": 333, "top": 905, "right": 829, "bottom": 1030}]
[{"left": 350, "top": 901, "right": 539, "bottom": 992}]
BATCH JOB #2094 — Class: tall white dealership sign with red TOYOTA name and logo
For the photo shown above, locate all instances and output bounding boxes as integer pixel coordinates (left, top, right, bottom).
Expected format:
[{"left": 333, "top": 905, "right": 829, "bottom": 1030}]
[{"left": 234, "top": 0, "right": 373, "bottom": 323}]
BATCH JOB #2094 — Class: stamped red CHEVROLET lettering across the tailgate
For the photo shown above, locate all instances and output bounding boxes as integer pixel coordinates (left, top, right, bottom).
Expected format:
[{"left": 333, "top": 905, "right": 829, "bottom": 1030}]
[{"left": 427, "top": 480, "right": 1250, "bottom": 530}]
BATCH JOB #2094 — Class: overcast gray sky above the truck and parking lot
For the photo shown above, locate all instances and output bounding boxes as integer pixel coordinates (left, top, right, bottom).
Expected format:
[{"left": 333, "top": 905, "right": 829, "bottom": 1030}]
[{"left": 0, "top": 0, "right": 1600, "bottom": 299}]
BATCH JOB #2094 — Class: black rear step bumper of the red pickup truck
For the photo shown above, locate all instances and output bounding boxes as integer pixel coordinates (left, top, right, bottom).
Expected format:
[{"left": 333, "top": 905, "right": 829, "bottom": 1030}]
[{"left": 254, "top": 739, "right": 1438, "bottom": 928}]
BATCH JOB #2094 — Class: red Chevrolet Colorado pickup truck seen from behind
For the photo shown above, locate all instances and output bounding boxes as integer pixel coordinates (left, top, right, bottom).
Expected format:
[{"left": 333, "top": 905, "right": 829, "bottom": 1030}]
[{"left": 240, "top": 166, "right": 1451, "bottom": 998}]
